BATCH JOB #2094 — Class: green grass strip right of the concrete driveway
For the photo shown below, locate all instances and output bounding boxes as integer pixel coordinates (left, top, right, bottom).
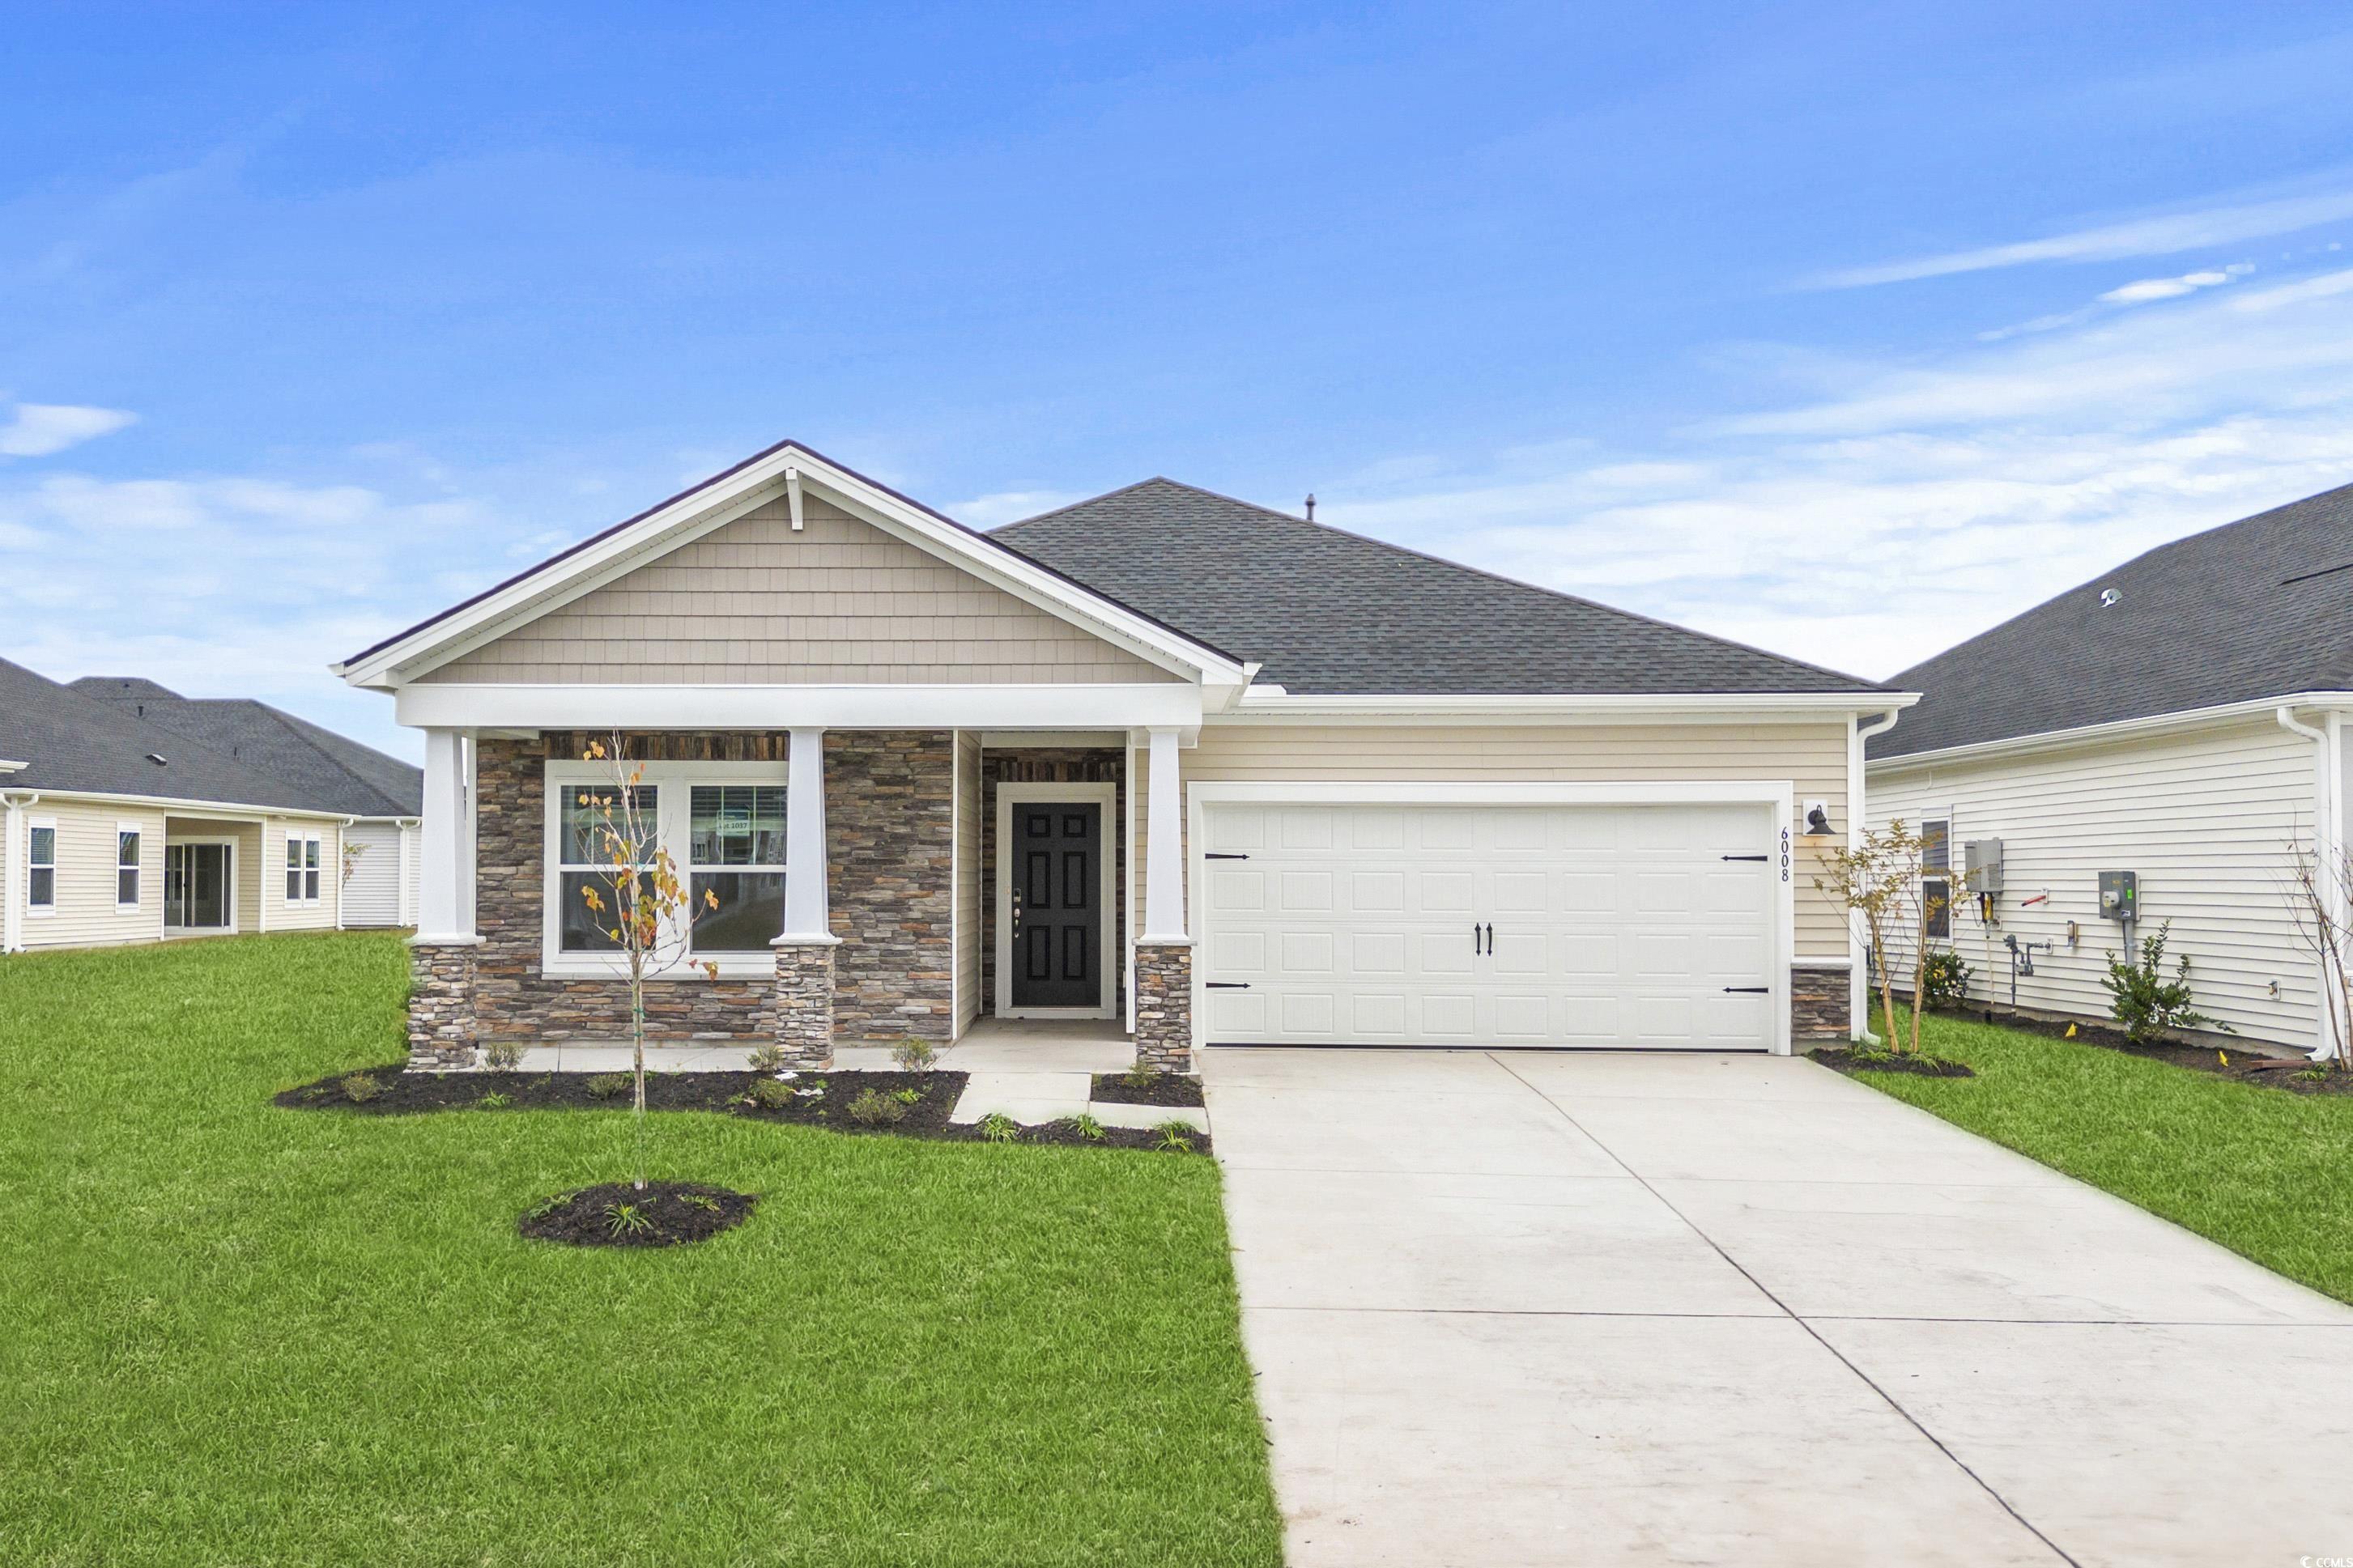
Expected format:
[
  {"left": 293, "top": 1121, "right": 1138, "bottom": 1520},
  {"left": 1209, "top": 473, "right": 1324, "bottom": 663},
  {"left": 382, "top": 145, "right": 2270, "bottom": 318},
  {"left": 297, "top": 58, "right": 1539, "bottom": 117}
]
[{"left": 1835, "top": 1013, "right": 2353, "bottom": 1302}]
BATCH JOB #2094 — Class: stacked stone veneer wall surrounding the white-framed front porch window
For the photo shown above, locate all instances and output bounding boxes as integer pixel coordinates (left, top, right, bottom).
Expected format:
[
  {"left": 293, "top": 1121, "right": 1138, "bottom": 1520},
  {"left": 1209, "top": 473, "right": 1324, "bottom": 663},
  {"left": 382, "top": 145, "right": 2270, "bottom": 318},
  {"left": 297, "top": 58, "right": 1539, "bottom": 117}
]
[{"left": 463, "top": 731, "right": 953, "bottom": 1048}]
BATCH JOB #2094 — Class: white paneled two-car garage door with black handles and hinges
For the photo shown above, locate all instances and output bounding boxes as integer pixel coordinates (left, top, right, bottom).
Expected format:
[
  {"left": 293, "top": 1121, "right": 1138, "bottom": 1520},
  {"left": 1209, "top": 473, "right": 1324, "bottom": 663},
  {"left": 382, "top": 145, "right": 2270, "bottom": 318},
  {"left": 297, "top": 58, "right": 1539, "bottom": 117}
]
[{"left": 1200, "top": 801, "right": 1779, "bottom": 1051}]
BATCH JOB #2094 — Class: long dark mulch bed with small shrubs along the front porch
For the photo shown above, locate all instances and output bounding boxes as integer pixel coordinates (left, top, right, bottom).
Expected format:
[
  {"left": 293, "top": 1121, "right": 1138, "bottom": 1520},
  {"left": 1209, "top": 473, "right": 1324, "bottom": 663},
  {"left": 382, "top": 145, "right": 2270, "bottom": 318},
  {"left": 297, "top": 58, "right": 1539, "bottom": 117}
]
[{"left": 273, "top": 1063, "right": 1210, "bottom": 1154}]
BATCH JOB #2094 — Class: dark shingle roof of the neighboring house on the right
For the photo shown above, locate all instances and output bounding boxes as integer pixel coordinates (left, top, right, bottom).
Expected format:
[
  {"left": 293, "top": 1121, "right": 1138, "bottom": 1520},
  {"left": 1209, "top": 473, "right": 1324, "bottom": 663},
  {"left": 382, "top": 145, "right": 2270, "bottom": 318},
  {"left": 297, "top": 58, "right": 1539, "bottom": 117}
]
[{"left": 1870, "top": 484, "right": 2353, "bottom": 759}]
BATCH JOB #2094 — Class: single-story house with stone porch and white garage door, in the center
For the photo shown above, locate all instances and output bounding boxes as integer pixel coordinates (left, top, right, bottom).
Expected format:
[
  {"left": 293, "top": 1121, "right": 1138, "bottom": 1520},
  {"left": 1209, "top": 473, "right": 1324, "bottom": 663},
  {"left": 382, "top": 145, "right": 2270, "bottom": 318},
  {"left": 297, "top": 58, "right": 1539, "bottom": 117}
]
[{"left": 338, "top": 442, "right": 1911, "bottom": 1067}]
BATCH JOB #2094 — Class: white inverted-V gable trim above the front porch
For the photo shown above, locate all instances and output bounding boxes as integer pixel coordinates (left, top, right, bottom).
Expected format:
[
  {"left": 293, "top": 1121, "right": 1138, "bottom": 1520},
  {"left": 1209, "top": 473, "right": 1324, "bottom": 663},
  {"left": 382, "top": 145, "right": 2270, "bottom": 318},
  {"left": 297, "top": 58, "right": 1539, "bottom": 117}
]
[{"left": 334, "top": 442, "right": 1249, "bottom": 689}]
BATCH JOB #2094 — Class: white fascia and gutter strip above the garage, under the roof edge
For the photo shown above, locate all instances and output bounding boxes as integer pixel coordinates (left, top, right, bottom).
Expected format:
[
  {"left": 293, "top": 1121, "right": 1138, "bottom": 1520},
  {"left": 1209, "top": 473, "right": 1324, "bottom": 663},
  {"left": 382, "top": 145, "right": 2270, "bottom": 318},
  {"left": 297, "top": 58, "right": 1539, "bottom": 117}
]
[{"left": 1205, "top": 689, "right": 1920, "bottom": 724}]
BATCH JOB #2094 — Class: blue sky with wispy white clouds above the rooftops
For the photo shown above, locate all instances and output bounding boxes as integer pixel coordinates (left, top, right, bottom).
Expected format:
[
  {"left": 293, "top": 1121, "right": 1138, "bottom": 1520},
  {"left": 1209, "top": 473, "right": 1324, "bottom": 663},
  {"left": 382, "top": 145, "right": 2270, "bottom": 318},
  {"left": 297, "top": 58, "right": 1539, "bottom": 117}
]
[{"left": 0, "top": 2, "right": 2353, "bottom": 754}]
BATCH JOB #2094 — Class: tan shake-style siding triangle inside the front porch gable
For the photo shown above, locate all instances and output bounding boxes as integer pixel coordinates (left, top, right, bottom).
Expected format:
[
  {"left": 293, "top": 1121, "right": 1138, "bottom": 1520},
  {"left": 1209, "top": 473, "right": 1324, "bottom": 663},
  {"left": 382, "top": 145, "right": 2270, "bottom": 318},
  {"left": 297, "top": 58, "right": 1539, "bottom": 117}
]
[{"left": 423, "top": 496, "right": 1176, "bottom": 686}]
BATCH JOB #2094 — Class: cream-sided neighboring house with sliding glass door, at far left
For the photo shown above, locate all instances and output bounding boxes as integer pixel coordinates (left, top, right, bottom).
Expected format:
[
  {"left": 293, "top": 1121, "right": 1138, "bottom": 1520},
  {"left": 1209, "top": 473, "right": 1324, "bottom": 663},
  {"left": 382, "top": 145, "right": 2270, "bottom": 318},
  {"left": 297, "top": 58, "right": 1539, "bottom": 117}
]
[{"left": 0, "top": 661, "right": 421, "bottom": 952}]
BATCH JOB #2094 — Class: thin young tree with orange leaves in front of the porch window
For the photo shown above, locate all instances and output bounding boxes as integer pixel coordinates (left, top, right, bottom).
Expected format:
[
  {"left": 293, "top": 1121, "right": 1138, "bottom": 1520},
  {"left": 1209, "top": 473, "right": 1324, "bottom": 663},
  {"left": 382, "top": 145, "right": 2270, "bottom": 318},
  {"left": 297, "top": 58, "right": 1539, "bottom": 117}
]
[{"left": 564, "top": 731, "right": 720, "bottom": 1192}]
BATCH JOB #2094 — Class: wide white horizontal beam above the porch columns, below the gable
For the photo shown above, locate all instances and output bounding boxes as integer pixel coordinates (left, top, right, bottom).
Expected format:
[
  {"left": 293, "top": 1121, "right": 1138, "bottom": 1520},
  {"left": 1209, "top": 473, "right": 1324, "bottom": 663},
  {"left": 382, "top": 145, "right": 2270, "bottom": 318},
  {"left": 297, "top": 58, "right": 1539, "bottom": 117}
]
[{"left": 393, "top": 682, "right": 1200, "bottom": 729}]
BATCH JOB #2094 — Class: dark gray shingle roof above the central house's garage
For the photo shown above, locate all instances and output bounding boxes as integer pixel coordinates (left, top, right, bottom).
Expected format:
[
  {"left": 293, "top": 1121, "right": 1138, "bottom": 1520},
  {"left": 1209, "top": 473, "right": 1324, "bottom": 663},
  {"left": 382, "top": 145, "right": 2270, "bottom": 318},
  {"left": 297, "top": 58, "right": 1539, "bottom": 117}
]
[{"left": 990, "top": 479, "right": 1885, "bottom": 696}]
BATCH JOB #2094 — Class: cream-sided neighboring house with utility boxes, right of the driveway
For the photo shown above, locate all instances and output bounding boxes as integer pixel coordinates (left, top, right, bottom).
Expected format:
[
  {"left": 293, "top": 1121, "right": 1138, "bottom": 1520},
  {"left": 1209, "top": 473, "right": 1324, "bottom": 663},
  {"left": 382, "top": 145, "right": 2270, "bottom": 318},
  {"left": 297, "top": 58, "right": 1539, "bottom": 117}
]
[{"left": 1868, "top": 487, "right": 2353, "bottom": 1048}]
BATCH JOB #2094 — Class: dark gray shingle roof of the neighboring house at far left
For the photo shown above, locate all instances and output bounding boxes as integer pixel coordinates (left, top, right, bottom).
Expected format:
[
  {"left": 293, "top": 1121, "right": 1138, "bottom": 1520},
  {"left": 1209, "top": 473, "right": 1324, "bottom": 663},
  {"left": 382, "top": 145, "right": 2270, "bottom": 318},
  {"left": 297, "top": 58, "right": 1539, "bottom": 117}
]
[{"left": 0, "top": 658, "right": 421, "bottom": 816}]
